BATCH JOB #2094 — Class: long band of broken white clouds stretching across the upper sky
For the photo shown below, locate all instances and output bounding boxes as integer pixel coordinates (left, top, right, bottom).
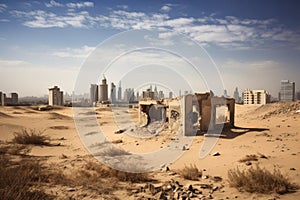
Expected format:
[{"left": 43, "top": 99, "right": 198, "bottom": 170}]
[{"left": 11, "top": 6, "right": 300, "bottom": 50}]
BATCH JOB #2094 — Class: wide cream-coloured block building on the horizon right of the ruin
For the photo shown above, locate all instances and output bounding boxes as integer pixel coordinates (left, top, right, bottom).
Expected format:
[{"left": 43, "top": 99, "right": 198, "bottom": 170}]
[{"left": 243, "top": 89, "right": 271, "bottom": 104}]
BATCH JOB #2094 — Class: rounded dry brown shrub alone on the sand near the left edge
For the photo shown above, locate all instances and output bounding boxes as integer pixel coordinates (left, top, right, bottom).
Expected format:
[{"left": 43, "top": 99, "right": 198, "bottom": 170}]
[{"left": 12, "top": 129, "right": 50, "bottom": 145}]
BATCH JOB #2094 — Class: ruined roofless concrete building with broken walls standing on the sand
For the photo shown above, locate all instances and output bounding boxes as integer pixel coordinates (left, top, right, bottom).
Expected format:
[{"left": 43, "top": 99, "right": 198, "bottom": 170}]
[{"left": 139, "top": 93, "right": 235, "bottom": 135}]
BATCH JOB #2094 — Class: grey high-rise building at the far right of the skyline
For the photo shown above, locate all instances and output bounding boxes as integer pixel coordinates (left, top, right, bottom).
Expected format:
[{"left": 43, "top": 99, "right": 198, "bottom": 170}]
[{"left": 279, "top": 80, "right": 295, "bottom": 102}]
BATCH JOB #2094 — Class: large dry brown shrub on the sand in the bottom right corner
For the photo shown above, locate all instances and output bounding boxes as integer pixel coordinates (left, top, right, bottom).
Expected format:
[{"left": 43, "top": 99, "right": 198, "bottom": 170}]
[{"left": 228, "top": 165, "right": 297, "bottom": 194}]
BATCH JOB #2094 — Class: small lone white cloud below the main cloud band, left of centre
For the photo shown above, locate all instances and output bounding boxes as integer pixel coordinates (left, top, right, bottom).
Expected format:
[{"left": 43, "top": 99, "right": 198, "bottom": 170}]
[{"left": 52, "top": 45, "right": 96, "bottom": 58}]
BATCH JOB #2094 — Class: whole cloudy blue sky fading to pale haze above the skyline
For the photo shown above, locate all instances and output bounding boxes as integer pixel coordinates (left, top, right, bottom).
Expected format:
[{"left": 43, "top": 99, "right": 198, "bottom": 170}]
[{"left": 0, "top": 0, "right": 300, "bottom": 97}]
